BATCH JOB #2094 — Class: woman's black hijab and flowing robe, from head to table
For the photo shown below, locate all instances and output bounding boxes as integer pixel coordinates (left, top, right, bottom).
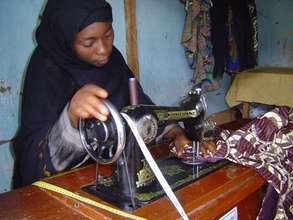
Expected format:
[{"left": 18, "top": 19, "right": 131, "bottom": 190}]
[{"left": 14, "top": 0, "right": 152, "bottom": 187}]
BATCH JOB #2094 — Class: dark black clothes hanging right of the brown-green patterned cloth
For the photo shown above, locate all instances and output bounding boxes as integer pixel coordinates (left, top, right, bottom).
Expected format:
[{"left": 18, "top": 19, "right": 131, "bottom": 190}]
[{"left": 210, "top": 0, "right": 258, "bottom": 78}]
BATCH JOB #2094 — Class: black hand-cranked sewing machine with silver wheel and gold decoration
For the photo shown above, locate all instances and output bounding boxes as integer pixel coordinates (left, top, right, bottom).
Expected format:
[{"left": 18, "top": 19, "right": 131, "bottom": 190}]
[{"left": 79, "top": 90, "right": 225, "bottom": 210}]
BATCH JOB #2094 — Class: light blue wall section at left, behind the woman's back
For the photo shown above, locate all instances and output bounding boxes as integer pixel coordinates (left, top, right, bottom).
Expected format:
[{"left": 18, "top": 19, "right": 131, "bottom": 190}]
[{"left": 0, "top": 0, "right": 42, "bottom": 192}]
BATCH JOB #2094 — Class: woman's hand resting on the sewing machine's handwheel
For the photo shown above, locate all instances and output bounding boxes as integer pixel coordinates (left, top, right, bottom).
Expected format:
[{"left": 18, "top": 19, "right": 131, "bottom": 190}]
[{"left": 68, "top": 84, "right": 109, "bottom": 128}]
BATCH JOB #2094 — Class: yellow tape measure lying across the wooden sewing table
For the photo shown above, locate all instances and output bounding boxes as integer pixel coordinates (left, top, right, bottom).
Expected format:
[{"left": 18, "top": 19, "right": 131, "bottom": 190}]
[{"left": 32, "top": 181, "right": 146, "bottom": 220}]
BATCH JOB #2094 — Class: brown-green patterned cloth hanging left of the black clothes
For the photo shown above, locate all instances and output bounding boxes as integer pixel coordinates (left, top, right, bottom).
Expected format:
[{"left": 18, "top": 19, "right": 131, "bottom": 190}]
[{"left": 182, "top": 0, "right": 219, "bottom": 90}]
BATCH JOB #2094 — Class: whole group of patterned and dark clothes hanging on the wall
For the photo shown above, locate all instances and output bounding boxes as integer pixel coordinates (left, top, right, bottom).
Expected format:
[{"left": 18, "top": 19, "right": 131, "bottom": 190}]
[{"left": 181, "top": 0, "right": 258, "bottom": 91}]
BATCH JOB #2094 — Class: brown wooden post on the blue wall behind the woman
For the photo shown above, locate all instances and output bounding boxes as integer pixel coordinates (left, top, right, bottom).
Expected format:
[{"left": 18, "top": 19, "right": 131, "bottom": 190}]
[{"left": 124, "top": 0, "right": 139, "bottom": 79}]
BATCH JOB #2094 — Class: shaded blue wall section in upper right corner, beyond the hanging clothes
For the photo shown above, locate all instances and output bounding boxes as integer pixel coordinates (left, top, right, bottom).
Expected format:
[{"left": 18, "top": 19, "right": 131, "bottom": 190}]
[{"left": 256, "top": 0, "right": 293, "bottom": 67}]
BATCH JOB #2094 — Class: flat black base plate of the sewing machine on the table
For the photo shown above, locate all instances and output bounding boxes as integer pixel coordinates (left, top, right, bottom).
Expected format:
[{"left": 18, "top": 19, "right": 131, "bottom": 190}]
[{"left": 82, "top": 158, "right": 229, "bottom": 211}]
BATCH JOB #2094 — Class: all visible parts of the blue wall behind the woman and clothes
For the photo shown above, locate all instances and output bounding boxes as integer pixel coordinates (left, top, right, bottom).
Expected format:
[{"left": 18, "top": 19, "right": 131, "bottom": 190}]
[{"left": 0, "top": 0, "right": 293, "bottom": 193}]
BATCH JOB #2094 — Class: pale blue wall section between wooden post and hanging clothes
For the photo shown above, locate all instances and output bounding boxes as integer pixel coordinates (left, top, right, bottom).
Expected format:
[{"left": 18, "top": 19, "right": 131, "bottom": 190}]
[{"left": 137, "top": 0, "right": 192, "bottom": 105}]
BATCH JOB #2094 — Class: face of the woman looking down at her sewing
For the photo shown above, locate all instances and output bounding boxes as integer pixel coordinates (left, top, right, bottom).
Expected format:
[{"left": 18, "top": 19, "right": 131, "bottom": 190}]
[{"left": 74, "top": 22, "right": 114, "bottom": 67}]
